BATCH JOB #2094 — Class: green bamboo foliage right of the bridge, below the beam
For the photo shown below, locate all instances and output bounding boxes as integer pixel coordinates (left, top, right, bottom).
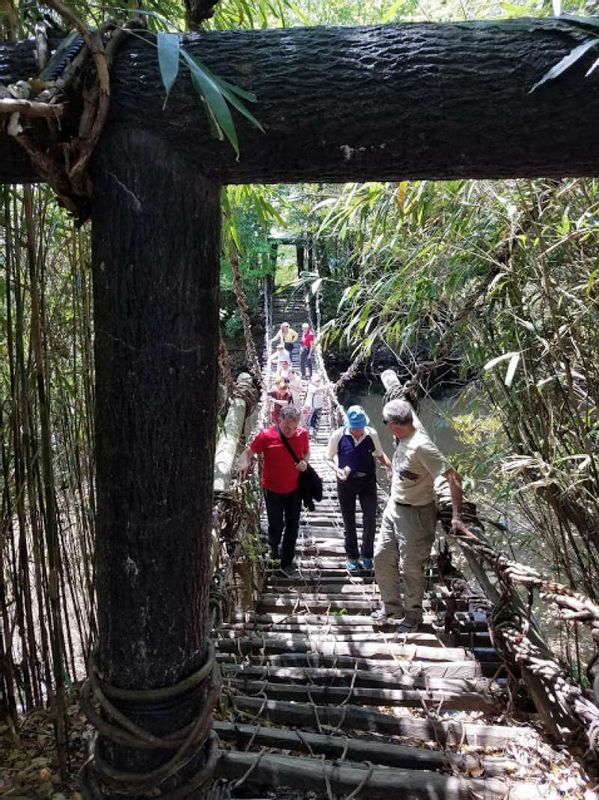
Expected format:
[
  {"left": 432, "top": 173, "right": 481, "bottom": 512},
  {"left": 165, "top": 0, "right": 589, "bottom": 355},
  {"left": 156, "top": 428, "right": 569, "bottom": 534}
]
[{"left": 318, "top": 175, "right": 599, "bottom": 596}]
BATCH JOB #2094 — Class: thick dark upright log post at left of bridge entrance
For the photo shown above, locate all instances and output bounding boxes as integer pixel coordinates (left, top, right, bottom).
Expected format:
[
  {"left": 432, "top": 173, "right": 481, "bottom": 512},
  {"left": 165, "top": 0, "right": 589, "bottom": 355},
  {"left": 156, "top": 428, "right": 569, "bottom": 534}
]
[{"left": 88, "top": 130, "right": 220, "bottom": 792}]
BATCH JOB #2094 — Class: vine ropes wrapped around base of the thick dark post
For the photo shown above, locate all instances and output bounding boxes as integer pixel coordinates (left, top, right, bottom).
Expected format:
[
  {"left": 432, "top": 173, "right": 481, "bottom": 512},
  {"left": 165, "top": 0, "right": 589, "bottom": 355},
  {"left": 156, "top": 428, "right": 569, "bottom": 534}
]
[{"left": 80, "top": 643, "right": 221, "bottom": 800}]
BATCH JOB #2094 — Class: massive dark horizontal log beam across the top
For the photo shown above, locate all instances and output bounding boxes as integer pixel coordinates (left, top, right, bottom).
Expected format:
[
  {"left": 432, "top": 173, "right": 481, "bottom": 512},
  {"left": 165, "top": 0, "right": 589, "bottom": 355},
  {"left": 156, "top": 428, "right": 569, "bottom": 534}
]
[{"left": 0, "top": 19, "right": 599, "bottom": 183}]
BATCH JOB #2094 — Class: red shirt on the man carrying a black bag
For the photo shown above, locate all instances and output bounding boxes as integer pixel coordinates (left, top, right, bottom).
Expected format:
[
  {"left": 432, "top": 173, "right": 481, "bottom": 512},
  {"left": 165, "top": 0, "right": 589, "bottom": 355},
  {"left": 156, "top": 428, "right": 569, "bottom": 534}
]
[{"left": 249, "top": 425, "right": 310, "bottom": 494}]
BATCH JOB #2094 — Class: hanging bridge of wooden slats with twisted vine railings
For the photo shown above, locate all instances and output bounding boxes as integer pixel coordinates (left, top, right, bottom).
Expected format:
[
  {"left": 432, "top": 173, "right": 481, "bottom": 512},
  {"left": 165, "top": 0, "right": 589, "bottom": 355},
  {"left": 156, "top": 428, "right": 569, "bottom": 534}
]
[{"left": 203, "top": 290, "right": 598, "bottom": 800}]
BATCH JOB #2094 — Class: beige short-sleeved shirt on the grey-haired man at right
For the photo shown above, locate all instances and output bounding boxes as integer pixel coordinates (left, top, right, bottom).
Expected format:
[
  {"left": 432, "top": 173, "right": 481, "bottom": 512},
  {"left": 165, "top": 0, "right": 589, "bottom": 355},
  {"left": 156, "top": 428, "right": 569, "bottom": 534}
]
[{"left": 391, "top": 429, "right": 450, "bottom": 506}]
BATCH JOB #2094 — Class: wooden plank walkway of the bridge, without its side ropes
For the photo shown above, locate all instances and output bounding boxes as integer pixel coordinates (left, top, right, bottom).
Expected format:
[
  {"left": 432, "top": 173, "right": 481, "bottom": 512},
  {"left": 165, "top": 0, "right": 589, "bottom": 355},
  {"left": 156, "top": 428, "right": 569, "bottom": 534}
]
[{"left": 215, "top": 296, "right": 568, "bottom": 800}]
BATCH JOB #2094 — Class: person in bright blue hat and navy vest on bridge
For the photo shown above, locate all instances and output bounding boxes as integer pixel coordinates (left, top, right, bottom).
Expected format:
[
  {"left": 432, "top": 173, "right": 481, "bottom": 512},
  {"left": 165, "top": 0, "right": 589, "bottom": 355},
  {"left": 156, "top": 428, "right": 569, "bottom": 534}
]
[{"left": 326, "top": 406, "right": 391, "bottom": 572}]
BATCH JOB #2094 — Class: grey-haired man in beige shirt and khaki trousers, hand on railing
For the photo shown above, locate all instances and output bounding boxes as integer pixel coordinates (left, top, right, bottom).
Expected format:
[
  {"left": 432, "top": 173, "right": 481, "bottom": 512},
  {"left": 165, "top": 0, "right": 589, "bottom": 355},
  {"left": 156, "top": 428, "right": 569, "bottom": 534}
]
[{"left": 372, "top": 400, "right": 466, "bottom": 634}]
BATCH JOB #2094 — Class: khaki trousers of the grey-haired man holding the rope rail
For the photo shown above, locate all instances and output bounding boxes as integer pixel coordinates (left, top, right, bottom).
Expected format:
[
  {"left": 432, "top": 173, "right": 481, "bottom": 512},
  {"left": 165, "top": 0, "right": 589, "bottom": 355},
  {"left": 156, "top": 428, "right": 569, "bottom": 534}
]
[{"left": 374, "top": 499, "right": 437, "bottom": 619}]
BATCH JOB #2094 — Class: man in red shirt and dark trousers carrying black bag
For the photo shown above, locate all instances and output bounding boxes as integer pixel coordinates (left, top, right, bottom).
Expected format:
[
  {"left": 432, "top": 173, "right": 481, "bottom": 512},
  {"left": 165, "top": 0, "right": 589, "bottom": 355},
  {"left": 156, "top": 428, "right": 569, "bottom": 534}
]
[{"left": 239, "top": 406, "right": 310, "bottom": 574}]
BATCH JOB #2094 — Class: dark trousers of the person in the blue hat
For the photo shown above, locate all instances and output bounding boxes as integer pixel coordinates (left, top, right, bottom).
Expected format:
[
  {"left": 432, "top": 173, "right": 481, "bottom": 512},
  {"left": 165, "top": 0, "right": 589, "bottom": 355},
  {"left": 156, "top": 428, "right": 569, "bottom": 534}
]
[{"left": 337, "top": 475, "right": 377, "bottom": 559}]
